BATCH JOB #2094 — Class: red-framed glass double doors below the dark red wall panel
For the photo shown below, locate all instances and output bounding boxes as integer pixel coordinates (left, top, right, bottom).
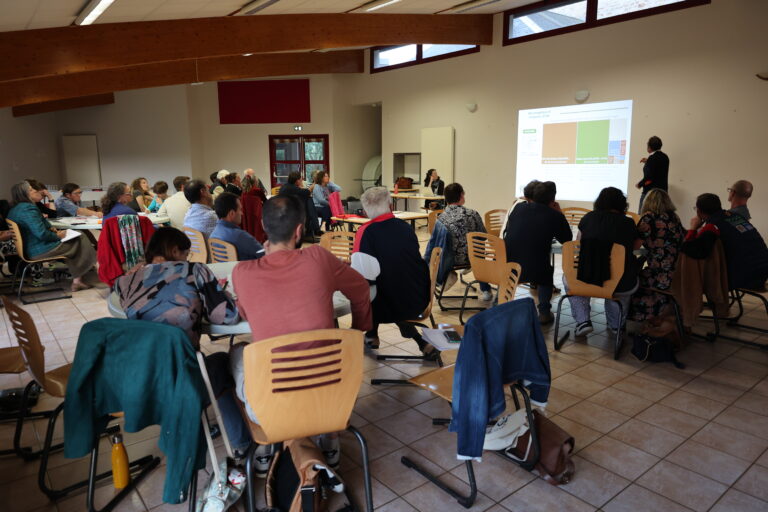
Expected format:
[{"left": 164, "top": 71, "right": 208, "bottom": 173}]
[{"left": 269, "top": 135, "right": 330, "bottom": 187}]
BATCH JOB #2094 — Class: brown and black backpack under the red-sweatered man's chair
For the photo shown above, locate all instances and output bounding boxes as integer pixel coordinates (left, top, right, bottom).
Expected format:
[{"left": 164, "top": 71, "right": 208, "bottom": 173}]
[{"left": 264, "top": 437, "right": 351, "bottom": 512}]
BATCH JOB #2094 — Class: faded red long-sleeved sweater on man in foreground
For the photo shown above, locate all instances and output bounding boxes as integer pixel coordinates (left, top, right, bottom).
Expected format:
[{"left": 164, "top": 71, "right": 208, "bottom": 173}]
[{"left": 232, "top": 245, "right": 371, "bottom": 341}]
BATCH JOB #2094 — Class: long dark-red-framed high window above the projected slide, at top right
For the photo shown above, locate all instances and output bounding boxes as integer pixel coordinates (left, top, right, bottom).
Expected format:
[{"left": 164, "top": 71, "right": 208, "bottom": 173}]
[{"left": 503, "top": 0, "right": 711, "bottom": 45}]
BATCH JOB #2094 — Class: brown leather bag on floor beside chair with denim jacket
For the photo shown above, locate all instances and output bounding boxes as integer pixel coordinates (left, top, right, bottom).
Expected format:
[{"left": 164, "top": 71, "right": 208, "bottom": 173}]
[{"left": 506, "top": 409, "right": 576, "bottom": 485}]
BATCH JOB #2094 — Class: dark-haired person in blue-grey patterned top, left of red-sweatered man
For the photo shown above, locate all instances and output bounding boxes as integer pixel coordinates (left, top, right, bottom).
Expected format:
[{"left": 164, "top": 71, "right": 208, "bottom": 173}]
[{"left": 113, "top": 228, "right": 250, "bottom": 452}]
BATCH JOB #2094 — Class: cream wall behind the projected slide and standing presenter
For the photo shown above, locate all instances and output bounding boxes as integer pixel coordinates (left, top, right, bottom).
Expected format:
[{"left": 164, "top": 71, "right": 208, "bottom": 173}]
[{"left": 338, "top": 0, "right": 768, "bottom": 233}]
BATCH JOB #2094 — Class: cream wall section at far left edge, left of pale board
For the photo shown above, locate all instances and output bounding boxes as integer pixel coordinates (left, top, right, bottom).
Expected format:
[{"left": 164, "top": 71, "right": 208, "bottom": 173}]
[{"left": 0, "top": 108, "right": 61, "bottom": 189}]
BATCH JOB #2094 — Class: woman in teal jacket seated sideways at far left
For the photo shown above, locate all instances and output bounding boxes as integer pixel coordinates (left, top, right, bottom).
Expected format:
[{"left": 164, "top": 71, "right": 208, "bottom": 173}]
[{"left": 8, "top": 181, "right": 96, "bottom": 292}]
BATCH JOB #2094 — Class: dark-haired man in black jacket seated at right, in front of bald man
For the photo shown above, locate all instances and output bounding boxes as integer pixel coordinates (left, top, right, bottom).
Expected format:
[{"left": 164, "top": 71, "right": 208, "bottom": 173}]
[{"left": 681, "top": 194, "right": 768, "bottom": 290}]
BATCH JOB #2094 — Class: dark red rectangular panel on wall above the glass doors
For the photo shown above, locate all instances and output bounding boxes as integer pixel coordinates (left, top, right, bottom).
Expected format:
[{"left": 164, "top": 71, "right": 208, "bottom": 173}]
[{"left": 218, "top": 78, "right": 311, "bottom": 124}]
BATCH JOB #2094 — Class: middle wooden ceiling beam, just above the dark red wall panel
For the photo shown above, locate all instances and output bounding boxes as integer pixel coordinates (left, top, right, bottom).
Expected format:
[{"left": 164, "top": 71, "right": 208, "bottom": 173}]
[{"left": 0, "top": 50, "right": 365, "bottom": 108}]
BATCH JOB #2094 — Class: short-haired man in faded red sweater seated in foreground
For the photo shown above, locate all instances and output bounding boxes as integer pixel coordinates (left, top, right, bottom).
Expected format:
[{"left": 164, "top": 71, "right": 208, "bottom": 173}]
[{"left": 231, "top": 195, "right": 371, "bottom": 475}]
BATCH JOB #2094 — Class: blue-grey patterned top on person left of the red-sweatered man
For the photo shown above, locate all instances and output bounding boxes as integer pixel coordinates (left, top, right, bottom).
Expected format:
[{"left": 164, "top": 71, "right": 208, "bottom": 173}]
[{"left": 114, "top": 261, "right": 239, "bottom": 348}]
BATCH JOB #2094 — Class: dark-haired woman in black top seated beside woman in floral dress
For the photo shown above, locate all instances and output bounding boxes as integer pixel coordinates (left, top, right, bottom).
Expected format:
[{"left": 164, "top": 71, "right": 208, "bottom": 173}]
[{"left": 563, "top": 187, "right": 641, "bottom": 336}]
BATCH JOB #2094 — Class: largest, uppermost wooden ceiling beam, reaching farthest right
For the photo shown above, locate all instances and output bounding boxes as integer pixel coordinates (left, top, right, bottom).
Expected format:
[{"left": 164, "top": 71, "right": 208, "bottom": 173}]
[{"left": 0, "top": 13, "right": 493, "bottom": 82}]
